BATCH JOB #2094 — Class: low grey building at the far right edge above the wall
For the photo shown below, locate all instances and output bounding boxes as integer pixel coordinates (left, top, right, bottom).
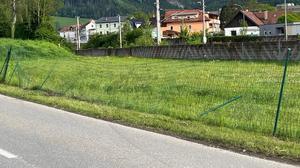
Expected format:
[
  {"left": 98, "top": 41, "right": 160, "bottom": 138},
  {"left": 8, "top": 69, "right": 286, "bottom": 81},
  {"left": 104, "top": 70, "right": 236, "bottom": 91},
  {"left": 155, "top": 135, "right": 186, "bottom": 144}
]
[{"left": 260, "top": 22, "right": 300, "bottom": 36}]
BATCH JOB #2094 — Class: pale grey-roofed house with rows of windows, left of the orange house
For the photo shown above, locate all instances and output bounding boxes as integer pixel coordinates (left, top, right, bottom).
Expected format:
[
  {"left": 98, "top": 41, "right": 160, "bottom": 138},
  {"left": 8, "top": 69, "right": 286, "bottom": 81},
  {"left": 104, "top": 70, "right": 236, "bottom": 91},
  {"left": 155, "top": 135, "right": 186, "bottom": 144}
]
[{"left": 96, "top": 16, "right": 127, "bottom": 34}]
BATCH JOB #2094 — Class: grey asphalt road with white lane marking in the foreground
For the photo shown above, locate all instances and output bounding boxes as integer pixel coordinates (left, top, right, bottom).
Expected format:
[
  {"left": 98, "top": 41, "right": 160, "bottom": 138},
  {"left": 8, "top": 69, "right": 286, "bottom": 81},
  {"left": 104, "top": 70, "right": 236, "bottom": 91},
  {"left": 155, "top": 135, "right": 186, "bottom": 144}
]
[{"left": 0, "top": 95, "right": 296, "bottom": 168}]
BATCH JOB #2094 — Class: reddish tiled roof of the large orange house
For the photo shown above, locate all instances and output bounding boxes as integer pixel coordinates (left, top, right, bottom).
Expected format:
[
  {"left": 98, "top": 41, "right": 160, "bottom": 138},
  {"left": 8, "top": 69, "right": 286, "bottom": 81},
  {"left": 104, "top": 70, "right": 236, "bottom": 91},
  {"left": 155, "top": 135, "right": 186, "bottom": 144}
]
[{"left": 163, "top": 9, "right": 210, "bottom": 23}]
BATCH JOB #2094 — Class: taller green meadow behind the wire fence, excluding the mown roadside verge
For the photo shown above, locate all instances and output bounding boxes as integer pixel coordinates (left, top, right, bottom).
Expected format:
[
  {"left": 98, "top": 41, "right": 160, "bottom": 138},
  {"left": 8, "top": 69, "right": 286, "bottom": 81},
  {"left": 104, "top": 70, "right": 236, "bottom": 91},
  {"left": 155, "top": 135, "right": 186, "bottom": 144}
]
[{"left": 0, "top": 39, "right": 300, "bottom": 161}]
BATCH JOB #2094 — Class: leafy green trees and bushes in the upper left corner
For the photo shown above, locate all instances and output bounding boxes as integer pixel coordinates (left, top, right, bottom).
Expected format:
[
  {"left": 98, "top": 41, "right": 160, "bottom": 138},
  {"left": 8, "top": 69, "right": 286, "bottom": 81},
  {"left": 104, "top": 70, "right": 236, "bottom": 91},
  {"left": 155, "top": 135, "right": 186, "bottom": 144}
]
[{"left": 0, "top": 0, "right": 63, "bottom": 41}]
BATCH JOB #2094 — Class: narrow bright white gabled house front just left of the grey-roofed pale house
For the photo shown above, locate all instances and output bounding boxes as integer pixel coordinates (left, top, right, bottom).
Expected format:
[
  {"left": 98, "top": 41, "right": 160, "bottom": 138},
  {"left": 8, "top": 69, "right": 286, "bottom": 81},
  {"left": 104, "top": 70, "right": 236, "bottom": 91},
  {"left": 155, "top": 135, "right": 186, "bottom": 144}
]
[{"left": 80, "top": 20, "right": 96, "bottom": 43}]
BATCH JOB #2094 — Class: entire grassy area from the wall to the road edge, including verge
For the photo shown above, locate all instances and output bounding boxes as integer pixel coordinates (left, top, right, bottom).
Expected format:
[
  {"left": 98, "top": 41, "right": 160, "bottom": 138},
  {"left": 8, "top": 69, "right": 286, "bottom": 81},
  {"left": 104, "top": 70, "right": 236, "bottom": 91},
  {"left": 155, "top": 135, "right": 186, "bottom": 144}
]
[{"left": 0, "top": 39, "right": 300, "bottom": 161}]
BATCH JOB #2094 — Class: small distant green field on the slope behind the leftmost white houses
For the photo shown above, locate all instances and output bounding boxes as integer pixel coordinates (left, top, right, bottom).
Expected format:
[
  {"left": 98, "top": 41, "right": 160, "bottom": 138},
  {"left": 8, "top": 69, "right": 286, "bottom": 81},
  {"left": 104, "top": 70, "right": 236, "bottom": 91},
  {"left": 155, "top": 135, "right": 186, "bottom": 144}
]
[{"left": 52, "top": 16, "right": 90, "bottom": 28}]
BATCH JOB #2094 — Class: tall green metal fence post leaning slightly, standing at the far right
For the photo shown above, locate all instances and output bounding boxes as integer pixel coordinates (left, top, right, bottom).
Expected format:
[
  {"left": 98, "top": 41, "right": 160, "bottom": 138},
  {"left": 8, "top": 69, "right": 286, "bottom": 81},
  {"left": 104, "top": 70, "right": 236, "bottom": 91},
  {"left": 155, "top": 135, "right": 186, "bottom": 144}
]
[{"left": 273, "top": 48, "right": 292, "bottom": 136}]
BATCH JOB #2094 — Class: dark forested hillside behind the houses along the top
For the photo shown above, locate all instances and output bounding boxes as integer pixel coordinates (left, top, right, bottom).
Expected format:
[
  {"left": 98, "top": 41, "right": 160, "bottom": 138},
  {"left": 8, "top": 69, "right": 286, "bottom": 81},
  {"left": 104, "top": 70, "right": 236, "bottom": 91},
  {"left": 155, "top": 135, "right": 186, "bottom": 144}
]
[{"left": 58, "top": 0, "right": 300, "bottom": 18}]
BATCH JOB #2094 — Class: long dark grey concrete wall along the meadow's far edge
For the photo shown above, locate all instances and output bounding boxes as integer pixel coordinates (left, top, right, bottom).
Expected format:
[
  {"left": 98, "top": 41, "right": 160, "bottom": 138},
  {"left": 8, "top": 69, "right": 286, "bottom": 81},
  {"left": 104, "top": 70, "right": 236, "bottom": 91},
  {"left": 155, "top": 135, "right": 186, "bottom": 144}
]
[{"left": 77, "top": 41, "right": 300, "bottom": 60}]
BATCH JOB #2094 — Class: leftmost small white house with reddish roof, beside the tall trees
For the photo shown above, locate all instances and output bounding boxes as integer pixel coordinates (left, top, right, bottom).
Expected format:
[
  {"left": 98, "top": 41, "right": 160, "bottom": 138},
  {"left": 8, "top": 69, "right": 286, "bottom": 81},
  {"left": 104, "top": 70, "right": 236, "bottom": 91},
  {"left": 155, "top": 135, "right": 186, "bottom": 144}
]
[{"left": 59, "top": 25, "right": 82, "bottom": 43}]
